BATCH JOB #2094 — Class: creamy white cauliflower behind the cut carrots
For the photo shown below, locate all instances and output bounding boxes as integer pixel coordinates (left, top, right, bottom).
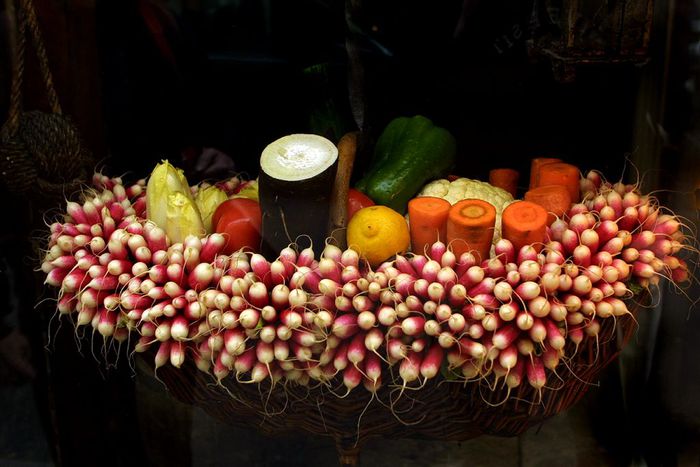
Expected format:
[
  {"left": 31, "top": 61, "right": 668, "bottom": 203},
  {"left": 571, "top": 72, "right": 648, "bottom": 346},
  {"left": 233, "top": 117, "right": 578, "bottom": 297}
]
[{"left": 418, "top": 178, "right": 513, "bottom": 243}]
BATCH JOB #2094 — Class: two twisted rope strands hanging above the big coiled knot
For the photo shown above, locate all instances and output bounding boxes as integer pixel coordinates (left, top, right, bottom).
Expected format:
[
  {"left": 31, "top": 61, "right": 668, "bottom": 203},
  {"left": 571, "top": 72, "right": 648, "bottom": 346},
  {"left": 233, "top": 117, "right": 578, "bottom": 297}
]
[{"left": 6, "top": 0, "right": 62, "bottom": 134}]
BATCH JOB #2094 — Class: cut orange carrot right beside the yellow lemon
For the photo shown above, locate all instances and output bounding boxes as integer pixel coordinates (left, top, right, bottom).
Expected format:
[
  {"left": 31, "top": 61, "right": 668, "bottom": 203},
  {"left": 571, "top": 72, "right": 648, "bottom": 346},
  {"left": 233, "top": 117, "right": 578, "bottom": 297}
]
[{"left": 408, "top": 196, "right": 452, "bottom": 254}]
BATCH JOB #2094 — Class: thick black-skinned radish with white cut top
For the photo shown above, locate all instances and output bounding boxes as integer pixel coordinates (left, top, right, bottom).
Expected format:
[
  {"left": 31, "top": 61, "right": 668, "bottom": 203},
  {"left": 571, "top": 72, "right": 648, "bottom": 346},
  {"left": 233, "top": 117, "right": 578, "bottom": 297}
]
[{"left": 258, "top": 134, "right": 338, "bottom": 259}]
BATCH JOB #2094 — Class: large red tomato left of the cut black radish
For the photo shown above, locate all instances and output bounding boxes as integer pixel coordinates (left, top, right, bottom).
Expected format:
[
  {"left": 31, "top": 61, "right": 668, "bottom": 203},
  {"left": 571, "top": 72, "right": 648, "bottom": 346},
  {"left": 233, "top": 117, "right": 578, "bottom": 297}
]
[{"left": 212, "top": 198, "right": 262, "bottom": 255}]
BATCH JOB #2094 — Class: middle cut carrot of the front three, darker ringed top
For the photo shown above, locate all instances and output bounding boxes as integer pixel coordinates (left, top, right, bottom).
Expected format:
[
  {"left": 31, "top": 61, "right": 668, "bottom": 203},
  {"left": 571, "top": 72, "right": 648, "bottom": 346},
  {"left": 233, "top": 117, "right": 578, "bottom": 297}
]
[{"left": 447, "top": 199, "right": 496, "bottom": 261}]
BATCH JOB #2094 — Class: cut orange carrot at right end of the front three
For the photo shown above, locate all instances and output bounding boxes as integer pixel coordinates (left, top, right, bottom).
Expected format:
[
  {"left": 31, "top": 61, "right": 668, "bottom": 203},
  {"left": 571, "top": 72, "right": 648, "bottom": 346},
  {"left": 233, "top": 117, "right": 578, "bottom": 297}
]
[{"left": 501, "top": 201, "right": 547, "bottom": 252}]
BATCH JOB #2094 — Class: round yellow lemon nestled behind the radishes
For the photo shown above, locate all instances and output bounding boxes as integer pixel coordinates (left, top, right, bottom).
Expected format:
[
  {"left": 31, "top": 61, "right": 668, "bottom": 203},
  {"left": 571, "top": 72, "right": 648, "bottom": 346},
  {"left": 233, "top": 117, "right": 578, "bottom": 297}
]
[{"left": 347, "top": 205, "right": 410, "bottom": 267}]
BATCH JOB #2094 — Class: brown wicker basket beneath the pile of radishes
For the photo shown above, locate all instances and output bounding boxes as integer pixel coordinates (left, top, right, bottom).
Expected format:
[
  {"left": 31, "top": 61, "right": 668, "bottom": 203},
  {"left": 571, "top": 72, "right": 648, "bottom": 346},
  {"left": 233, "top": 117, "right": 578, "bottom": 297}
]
[{"left": 146, "top": 301, "right": 643, "bottom": 465}]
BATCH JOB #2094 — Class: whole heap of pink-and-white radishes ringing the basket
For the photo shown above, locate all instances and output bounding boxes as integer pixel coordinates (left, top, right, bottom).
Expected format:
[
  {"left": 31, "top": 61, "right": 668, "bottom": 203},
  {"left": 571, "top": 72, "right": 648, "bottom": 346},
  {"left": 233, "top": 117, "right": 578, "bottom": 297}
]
[{"left": 41, "top": 172, "right": 689, "bottom": 402}]
